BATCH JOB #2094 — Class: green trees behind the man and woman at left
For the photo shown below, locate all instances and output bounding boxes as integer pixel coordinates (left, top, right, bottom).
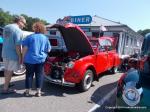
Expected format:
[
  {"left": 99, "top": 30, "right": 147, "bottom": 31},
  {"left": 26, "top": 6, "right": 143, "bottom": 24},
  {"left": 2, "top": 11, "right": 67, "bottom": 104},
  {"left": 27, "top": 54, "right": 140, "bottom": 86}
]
[{"left": 0, "top": 8, "right": 49, "bottom": 31}]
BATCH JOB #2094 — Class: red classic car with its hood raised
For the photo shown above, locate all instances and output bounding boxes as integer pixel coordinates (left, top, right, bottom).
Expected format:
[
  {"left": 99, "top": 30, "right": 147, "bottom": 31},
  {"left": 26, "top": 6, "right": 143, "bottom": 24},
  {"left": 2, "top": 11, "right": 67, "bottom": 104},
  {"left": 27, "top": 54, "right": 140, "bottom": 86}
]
[{"left": 44, "top": 23, "right": 120, "bottom": 91}]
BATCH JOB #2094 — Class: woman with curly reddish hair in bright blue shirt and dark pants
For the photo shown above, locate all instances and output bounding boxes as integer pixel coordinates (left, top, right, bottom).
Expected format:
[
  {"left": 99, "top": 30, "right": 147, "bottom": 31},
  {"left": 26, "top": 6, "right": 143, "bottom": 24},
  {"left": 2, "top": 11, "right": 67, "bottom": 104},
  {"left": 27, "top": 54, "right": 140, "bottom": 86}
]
[{"left": 22, "top": 22, "right": 51, "bottom": 97}]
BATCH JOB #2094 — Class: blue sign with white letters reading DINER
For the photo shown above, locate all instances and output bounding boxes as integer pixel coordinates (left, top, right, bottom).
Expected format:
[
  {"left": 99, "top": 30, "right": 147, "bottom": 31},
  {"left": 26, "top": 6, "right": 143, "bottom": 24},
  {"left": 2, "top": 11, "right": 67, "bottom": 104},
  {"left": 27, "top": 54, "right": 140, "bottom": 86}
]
[{"left": 70, "top": 15, "right": 92, "bottom": 24}]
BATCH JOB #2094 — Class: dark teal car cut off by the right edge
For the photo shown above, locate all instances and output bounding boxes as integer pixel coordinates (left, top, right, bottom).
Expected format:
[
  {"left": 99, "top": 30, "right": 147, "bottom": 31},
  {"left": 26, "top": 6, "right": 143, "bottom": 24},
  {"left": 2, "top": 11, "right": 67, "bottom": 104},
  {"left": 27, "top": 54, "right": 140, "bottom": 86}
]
[{"left": 116, "top": 34, "right": 150, "bottom": 112}]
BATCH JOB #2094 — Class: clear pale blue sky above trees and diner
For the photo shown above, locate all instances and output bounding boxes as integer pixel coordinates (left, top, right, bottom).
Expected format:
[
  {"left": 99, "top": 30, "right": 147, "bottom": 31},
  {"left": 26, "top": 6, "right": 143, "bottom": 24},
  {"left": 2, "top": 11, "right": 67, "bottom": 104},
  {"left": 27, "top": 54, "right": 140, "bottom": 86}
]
[{"left": 0, "top": 0, "right": 150, "bottom": 31}]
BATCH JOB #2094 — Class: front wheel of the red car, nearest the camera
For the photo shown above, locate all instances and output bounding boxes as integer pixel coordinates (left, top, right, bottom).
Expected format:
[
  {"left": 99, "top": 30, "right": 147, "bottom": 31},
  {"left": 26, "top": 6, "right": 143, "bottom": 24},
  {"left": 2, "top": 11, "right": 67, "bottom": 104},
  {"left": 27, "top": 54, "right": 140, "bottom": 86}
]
[{"left": 80, "top": 70, "right": 94, "bottom": 92}]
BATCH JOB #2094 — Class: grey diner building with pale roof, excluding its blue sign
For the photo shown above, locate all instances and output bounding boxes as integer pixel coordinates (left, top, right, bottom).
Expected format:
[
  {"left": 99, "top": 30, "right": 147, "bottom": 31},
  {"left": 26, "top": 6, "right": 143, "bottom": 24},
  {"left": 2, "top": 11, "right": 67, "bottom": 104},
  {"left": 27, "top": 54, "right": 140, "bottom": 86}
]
[{"left": 78, "top": 15, "right": 144, "bottom": 57}]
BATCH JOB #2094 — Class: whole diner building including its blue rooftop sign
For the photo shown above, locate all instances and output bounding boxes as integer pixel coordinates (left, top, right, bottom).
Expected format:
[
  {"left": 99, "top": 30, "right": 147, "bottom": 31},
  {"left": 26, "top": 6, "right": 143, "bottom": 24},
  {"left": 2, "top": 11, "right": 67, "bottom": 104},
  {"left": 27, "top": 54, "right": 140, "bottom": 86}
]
[{"left": 47, "top": 15, "right": 144, "bottom": 58}]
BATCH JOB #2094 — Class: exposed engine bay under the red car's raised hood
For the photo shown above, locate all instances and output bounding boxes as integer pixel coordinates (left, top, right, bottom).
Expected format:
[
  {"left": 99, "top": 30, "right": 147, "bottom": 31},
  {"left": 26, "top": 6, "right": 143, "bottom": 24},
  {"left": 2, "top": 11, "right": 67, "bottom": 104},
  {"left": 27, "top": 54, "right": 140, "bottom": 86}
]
[{"left": 44, "top": 52, "right": 80, "bottom": 79}]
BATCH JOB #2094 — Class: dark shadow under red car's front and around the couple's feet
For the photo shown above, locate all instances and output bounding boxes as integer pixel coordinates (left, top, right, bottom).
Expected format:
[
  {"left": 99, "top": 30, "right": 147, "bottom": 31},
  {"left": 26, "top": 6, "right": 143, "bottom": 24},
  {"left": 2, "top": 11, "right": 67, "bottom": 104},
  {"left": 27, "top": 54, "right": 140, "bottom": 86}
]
[{"left": 0, "top": 76, "right": 81, "bottom": 100}]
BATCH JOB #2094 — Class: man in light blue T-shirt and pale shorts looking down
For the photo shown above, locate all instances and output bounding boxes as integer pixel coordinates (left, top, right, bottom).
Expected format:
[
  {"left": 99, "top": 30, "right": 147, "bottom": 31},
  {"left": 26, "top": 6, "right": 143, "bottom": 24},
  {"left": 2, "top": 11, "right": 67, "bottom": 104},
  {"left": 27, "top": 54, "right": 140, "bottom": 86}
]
[{"left": 2, "top": 16, "right": 26, "bottom": 94}]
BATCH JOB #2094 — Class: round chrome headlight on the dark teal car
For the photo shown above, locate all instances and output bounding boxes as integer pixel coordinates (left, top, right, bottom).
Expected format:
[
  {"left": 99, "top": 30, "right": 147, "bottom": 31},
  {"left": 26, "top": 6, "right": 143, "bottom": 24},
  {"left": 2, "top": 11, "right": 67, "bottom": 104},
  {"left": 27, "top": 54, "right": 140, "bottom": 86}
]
[{"left": 122, "top": 87, "right": 142, "bottom": 106}]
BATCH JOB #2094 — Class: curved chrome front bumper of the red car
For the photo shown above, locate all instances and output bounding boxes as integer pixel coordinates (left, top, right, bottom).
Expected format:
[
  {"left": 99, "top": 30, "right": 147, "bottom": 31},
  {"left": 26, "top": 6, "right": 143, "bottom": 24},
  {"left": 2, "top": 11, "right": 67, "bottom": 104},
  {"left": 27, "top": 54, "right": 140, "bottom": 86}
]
[{"left": 44, "top": 75, "right": 75, "bottom": 87}]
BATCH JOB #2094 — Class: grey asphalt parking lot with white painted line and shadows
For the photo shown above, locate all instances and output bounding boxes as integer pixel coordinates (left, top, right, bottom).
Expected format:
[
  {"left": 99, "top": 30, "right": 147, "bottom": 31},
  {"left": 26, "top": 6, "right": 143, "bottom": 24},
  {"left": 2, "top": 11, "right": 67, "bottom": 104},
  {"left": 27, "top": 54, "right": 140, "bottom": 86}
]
[{"left": 0, "top": 73, "right": 121, "bottom": 112}]
